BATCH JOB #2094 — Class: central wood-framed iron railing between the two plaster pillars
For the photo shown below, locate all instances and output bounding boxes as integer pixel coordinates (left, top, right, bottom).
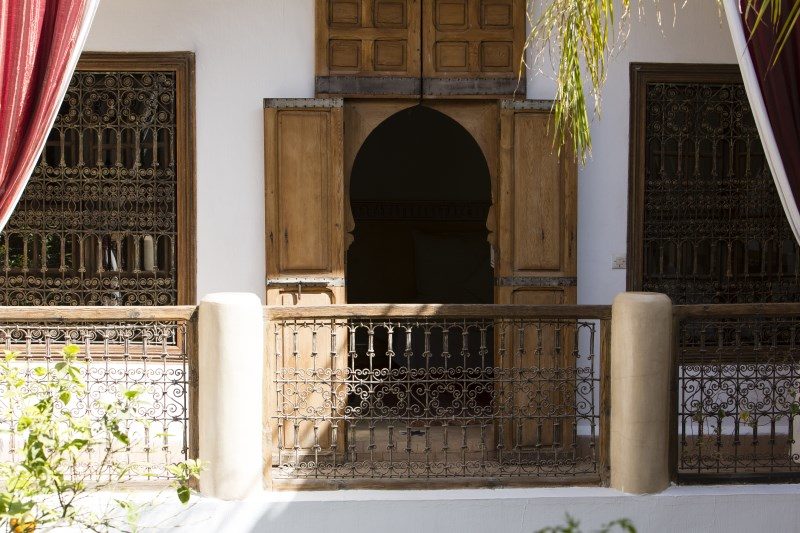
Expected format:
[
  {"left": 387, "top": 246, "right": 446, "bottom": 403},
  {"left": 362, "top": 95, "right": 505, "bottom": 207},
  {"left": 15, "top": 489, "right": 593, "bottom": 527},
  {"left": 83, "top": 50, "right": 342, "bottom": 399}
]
[{"left": 267, "top": 305, "right": 610, "bottom": 485}]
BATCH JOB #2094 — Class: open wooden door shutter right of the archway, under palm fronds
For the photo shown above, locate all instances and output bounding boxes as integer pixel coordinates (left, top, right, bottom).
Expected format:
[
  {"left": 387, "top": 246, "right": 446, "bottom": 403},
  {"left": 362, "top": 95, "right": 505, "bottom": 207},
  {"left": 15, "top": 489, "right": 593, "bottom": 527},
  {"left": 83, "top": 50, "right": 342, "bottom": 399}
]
[{"left": 495, "top": 101, "right": 578, "bottom": 449}]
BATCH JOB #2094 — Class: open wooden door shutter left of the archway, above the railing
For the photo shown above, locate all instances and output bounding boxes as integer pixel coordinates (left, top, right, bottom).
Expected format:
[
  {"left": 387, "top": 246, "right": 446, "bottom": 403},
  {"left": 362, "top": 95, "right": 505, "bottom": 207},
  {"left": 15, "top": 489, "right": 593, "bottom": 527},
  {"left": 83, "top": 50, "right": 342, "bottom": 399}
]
[{"left": 265, "top": 99, "right": 344, "bottom": 305}]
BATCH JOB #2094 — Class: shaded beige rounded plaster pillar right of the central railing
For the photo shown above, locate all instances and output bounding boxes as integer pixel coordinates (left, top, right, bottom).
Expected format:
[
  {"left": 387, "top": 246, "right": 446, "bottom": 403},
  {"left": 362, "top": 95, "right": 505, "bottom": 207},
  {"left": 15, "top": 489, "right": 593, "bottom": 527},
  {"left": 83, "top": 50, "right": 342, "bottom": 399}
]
[{"left": 610, "top": 292, "right": 673, "bottom": 494}]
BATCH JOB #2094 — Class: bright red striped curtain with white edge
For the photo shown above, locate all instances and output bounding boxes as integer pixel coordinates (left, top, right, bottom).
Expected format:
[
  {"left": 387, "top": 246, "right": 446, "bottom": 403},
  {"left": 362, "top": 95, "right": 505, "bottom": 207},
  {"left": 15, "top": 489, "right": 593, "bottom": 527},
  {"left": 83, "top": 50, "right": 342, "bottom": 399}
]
[{"left": 0, "top": 0, "right": 99, "bottom": 230}]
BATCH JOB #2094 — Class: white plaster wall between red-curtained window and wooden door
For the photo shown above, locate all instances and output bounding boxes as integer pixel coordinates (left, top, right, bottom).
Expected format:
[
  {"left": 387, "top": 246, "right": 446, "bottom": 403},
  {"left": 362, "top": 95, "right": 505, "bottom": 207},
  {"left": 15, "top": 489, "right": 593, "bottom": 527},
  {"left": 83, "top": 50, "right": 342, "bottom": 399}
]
[{"left": 86, "top": 0, "right": 314, "bottom": 298}]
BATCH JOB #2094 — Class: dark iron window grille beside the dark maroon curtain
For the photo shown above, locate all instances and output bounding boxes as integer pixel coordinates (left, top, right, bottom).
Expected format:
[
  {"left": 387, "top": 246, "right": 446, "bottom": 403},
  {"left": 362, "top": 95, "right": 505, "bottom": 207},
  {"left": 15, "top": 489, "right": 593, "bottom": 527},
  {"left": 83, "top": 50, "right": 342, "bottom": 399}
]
[{"left": 642, "top": 83, "right": 800, "bottom": 303}]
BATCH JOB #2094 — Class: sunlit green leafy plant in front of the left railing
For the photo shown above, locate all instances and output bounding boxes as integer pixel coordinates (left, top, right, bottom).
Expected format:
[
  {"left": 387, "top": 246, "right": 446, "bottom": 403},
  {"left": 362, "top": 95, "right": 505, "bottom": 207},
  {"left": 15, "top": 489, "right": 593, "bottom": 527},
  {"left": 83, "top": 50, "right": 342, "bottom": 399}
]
[{"left": 0, "top": 344, "right": 202, "bottom": 533}]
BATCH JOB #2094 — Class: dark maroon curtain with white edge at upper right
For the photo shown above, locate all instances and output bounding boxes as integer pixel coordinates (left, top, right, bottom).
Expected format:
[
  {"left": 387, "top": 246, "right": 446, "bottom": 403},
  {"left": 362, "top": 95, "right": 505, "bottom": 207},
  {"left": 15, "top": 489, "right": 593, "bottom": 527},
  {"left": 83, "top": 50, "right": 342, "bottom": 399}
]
[{"left": 724, "top": 0, "right": 800, "bottom": 242}]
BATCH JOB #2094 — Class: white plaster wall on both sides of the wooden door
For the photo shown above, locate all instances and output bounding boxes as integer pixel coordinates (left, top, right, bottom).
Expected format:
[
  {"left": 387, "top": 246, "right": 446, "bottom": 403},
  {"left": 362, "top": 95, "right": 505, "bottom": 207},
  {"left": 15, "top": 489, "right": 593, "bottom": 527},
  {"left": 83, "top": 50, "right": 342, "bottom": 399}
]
[{"left": 86, "top": 0, "right": 735, "bottom": 303}]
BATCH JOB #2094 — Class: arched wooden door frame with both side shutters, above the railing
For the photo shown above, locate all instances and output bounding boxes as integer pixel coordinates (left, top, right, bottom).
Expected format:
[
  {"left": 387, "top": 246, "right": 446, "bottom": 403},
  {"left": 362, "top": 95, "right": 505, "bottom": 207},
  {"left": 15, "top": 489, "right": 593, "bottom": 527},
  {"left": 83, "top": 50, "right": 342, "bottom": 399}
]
[{"left": 265, "top": 98, "right": 577, "bottom": 306}]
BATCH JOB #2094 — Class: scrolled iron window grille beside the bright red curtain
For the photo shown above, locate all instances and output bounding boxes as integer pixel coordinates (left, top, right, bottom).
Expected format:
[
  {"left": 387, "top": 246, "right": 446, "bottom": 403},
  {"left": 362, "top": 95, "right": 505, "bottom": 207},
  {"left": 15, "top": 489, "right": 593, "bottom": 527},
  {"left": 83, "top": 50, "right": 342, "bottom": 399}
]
[{"left": 0, "top": 71, "right": 177, "bottom": 305}]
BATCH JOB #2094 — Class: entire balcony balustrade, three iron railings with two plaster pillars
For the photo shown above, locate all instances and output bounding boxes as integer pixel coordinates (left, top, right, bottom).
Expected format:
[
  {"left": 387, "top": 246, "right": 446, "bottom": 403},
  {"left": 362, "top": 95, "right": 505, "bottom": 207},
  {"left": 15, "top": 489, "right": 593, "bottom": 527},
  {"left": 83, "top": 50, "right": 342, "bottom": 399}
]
[{"left": 6, "top": 295, "right": 800, "bottom": 494}]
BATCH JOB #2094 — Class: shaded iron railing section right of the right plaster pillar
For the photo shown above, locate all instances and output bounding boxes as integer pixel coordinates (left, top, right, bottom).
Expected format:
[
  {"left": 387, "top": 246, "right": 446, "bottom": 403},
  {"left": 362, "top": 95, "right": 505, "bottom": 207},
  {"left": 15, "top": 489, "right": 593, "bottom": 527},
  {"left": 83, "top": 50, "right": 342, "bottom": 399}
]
[{"left": 673, "top": 304, "right": 800, "bottom": 482}]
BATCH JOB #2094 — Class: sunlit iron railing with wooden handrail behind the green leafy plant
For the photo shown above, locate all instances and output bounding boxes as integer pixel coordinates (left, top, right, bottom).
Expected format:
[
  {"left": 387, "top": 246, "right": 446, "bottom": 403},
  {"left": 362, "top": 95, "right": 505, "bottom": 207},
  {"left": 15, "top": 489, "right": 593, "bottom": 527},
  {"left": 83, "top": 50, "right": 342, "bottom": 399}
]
[{"left": 0, "top": 306, "right": 197, "bottom": 481}]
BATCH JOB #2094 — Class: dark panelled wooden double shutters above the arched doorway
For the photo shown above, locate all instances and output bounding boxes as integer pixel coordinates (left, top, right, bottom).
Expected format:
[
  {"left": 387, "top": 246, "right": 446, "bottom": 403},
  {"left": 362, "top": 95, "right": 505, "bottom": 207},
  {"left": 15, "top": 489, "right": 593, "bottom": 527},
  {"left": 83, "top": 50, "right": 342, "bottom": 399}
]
[{"left": 316, "top": 0, "right": 526, "bottom": 98}]
